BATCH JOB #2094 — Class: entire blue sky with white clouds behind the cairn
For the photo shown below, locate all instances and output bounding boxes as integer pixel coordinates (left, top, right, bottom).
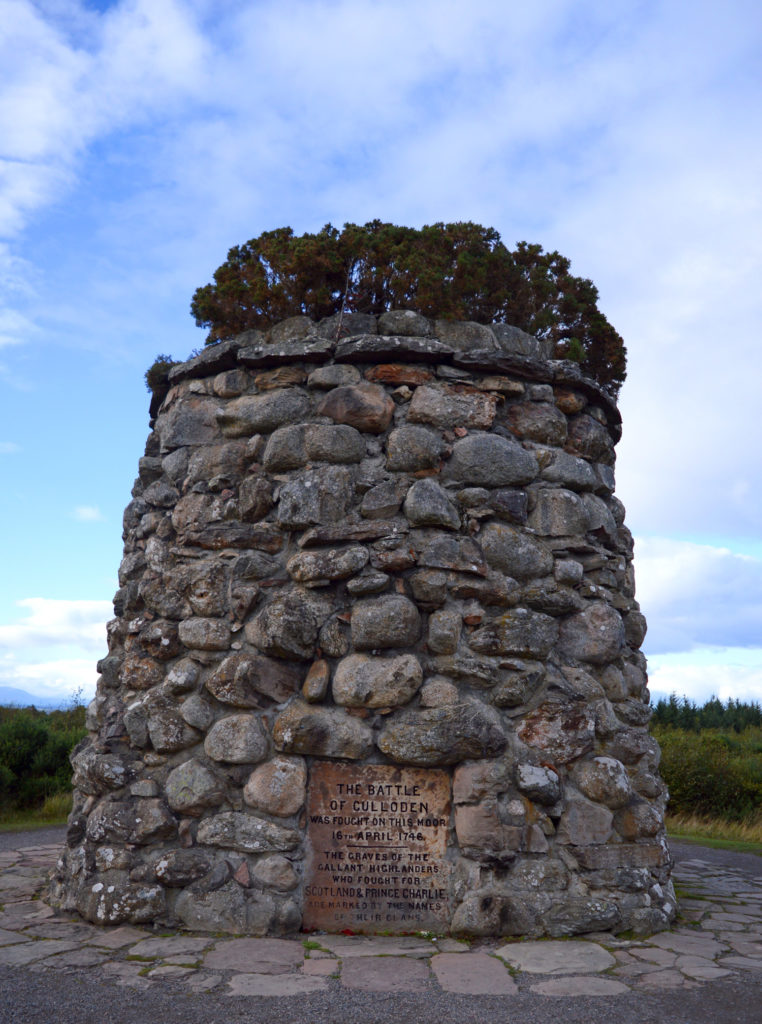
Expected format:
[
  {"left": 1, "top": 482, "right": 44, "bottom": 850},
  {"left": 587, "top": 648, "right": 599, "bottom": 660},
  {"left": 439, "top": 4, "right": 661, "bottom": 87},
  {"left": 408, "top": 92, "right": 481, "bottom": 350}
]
[{"left": 0, "top": 0, "right": 762, "bottom": 700}]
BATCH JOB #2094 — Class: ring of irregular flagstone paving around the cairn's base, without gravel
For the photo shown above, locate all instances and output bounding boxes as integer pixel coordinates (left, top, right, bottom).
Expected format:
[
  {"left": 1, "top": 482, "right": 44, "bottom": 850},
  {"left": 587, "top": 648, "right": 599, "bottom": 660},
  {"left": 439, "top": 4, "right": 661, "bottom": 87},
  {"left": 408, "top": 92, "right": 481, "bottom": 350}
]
[{"left": 0, "top": 845, "right": 762, "bottom": 999}]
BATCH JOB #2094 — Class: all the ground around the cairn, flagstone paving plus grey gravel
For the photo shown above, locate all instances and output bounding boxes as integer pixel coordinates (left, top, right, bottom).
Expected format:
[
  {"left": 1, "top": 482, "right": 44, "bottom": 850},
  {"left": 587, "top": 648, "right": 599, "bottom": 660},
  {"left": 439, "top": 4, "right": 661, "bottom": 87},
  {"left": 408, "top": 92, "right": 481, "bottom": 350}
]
[{"left": 0, "top": 828, "right": 762, "bottom": 1024}]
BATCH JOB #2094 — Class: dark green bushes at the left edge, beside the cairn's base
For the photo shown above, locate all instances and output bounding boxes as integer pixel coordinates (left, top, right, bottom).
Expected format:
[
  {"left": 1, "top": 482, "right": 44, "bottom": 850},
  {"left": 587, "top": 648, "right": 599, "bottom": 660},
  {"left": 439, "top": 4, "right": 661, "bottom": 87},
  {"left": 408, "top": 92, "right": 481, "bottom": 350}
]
[{"left": 0, "top": 708, "right": 85, "bottom": 811}]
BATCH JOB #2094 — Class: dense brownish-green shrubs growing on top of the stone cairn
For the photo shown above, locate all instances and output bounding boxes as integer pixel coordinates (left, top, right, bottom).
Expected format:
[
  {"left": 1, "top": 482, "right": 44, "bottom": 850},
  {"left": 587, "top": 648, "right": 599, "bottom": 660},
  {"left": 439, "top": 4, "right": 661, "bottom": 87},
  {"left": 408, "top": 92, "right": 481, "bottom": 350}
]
[{"left": 191, "top": 220, "right": 626, "bottom": 394}]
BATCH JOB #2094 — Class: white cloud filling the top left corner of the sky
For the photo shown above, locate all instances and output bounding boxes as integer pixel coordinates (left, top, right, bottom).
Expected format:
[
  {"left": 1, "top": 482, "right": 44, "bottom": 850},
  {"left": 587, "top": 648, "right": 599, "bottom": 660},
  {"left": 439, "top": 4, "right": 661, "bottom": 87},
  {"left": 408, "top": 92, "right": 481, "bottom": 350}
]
[{"left": 0, "top": 0, "right": 205, "bottom": 236}]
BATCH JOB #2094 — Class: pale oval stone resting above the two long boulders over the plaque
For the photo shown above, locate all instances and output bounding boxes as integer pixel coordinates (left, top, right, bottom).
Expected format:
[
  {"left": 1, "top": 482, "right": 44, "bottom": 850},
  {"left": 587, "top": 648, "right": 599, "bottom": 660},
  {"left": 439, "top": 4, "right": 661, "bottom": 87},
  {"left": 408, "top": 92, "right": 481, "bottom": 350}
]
[{"left": 333, "top": 654, "right": 423, "bottom": 708}]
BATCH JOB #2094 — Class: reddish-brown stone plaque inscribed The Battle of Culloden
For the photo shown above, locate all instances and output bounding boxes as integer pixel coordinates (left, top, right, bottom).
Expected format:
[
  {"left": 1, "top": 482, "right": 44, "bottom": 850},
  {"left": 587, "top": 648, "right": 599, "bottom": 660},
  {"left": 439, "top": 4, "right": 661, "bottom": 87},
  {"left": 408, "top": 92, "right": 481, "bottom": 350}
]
[{"left": 302, "top": 762, "right": 451, "bottom": 933}]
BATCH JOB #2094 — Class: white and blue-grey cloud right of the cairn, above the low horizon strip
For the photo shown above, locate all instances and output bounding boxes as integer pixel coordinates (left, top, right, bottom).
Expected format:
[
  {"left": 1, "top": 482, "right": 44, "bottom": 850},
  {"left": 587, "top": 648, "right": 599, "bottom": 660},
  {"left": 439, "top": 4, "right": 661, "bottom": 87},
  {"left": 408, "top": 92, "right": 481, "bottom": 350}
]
[{"left": 635, "top": 538, "right": 762, "bottom": 656}]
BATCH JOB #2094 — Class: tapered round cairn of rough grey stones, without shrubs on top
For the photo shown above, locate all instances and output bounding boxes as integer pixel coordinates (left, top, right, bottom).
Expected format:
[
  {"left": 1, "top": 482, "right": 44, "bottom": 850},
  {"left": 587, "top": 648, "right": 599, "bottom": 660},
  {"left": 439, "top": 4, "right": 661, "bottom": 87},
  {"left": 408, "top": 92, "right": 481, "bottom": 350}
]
[{"left": 51, "top": 310, "right": 675, "bottom": 936}]
